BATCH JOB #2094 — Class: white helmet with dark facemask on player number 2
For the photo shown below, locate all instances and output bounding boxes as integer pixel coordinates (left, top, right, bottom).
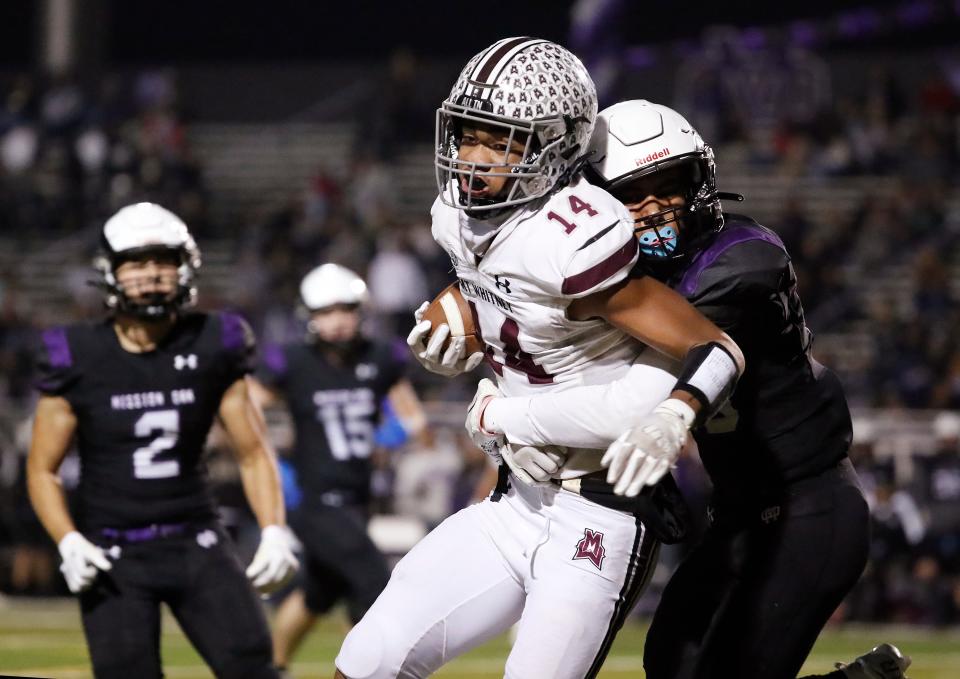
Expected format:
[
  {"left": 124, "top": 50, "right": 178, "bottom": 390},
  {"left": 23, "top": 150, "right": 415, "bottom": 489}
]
[{"left": 93, "top": 203, "right": 201, "bottom": 318}]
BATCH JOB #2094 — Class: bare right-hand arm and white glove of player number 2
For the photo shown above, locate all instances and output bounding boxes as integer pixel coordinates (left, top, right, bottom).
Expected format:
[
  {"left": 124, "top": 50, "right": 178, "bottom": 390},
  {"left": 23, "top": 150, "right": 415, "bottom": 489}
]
[{"left": 220, "top": 377, "right": 298, "bottom": 594}]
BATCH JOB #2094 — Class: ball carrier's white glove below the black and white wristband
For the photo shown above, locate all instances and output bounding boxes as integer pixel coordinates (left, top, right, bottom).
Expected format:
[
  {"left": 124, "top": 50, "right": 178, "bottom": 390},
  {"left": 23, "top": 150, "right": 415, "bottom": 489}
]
[{"left": 600, "top": 398, "right": 696, "bottom": 497}]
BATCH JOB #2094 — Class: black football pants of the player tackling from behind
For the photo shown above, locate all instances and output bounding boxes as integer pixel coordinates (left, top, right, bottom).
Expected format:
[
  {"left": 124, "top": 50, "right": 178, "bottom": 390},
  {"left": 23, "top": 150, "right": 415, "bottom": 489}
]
[{"left": 643, "top": 460, "right": 869, "bottom": 679}]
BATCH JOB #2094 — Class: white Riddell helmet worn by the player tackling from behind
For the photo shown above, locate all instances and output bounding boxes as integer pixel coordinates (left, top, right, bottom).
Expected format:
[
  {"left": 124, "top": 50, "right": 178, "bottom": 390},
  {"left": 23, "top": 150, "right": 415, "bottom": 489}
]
[{"left": 585, "top": 99, "right": 720, "bottom": 262}]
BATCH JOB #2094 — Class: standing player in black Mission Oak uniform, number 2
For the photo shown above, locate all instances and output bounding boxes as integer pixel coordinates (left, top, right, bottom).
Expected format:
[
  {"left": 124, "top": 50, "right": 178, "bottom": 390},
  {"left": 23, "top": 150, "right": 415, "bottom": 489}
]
[{"left": 27, "top": 203, "right": 297, "bottom": 679}]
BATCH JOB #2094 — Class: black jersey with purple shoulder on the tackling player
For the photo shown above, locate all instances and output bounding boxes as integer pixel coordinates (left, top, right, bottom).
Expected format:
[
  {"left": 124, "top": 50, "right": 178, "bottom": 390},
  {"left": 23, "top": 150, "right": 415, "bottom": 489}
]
[{"left": 668, "top": 215, "right": 852, "bottom": 498}]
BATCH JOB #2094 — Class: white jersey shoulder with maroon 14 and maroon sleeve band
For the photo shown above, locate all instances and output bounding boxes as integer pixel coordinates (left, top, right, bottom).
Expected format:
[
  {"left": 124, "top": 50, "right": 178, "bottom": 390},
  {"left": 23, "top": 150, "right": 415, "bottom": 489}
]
[{"left": 541, "top": 179, "right": 639, "bottom": 297}]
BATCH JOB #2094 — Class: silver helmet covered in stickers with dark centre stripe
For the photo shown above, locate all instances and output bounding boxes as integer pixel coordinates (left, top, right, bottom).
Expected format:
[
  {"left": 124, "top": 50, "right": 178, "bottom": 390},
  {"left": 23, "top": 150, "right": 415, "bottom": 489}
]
[{"left": 434, "top": 37, "right": 597, "bottom": 216}]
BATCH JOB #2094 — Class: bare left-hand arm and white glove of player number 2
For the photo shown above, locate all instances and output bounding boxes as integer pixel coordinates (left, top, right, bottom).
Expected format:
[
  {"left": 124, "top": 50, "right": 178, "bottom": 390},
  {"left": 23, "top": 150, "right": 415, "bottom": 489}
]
[{"left": 27, "top": 396, "right": 112, "bottom": 594}]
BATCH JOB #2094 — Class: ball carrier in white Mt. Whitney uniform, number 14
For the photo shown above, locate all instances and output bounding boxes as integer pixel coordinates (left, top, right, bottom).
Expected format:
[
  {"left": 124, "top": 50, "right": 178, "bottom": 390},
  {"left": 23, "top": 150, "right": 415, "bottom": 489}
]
[{"left": 336, "top": 37, "right": 743, "bottom": 679}]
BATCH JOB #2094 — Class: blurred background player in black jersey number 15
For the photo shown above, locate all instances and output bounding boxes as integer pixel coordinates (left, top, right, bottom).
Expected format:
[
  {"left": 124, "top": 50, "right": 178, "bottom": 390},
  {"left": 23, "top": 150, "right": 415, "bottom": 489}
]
[{"left": 251, "top": 264, "right": 426, "bottom": 667}]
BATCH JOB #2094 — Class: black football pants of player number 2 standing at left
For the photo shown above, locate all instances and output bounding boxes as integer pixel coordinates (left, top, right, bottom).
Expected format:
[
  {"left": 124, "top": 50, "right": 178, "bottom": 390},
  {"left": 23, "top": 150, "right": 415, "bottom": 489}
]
[{"left": 80, "top": 524, "right": 278, "bottom": 679}]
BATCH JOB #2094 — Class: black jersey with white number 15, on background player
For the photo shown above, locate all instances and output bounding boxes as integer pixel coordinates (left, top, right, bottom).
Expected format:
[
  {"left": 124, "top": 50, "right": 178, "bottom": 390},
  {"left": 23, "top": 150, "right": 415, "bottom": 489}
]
[{"left": 261, "top": 340, "right": 406, "bottom": 503}]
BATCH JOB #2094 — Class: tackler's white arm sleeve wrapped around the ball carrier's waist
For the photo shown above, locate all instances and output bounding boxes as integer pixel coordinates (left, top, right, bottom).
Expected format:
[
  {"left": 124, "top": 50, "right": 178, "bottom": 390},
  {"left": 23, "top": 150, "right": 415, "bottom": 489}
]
[{"left": 487, "top": 350, "right": 679, "bottom": 449}]
